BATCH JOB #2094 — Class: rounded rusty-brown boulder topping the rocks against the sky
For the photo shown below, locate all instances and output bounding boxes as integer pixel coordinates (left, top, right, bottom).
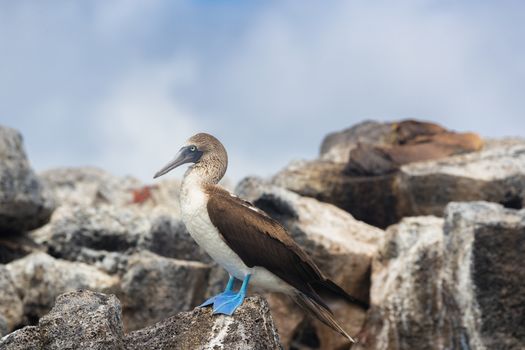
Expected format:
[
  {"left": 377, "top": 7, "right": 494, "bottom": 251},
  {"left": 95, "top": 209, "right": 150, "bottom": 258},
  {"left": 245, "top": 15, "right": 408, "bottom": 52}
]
[{"left": 321, "top": 120, "right": 483, "bottom": 169}]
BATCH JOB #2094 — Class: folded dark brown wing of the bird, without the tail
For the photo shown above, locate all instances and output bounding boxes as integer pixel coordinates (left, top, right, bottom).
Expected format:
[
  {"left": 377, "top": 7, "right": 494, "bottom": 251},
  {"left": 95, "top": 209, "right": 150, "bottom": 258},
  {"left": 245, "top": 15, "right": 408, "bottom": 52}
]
[{"left": 207, "top": 187, "right": 325, "bottom": 304}]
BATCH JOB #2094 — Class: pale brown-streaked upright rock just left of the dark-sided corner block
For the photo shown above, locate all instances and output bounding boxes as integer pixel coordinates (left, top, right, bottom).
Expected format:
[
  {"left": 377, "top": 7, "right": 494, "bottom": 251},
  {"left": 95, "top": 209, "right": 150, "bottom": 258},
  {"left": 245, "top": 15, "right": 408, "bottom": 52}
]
[{"left": 357, "top": 216, "right": 446, "bottom": 349}]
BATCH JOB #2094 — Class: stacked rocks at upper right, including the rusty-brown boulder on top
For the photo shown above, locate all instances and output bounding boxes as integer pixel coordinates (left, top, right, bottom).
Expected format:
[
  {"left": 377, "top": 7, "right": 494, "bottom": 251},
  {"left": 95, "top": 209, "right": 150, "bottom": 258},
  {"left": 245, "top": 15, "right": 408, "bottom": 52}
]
[{"left": 272, "top": 121, "right": 525, "bottom": 228}]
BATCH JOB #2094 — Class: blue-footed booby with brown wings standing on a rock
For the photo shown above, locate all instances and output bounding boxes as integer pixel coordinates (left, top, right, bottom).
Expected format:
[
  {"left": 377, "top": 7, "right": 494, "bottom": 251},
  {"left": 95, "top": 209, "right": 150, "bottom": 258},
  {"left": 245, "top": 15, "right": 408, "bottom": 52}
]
[{"left": 154, "top": 133, "right": 369, "bottom": 342}]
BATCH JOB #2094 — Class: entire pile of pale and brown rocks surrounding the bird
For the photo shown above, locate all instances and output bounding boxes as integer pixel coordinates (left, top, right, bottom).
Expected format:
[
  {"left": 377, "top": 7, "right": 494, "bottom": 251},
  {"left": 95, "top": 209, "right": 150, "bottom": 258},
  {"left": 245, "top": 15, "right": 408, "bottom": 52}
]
[{"left": 0, "top": 121, "right": 525, "bottom": 350}]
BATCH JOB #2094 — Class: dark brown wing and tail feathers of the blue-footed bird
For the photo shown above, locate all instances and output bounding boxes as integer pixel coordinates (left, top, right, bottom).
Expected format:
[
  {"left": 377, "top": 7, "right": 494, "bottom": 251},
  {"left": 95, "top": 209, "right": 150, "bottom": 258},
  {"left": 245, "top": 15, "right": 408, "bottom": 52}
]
[{"left": 206, "top": 185, "right": 368, "bottom": 341}]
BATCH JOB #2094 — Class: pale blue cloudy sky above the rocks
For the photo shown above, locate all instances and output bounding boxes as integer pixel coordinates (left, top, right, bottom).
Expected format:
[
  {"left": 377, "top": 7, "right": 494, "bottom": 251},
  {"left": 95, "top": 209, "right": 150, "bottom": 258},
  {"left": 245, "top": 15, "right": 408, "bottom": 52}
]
[{"left": 0, "top": 0, "right": 525, "bottom": 182}]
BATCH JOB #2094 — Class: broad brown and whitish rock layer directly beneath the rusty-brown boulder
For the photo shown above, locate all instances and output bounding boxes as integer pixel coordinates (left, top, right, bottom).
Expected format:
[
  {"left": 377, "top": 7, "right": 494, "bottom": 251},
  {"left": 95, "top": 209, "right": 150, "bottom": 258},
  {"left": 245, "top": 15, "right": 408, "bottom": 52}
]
[{"left": 272, "top": 135, "right": 525, "bottom": 227}]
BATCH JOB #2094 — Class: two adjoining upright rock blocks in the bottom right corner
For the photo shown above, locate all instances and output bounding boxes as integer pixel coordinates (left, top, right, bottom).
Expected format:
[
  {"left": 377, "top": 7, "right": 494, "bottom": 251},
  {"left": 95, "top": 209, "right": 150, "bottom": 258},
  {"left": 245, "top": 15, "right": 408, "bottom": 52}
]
[{"left": 357, "top": 202, "right": 525, "bottom": 350}]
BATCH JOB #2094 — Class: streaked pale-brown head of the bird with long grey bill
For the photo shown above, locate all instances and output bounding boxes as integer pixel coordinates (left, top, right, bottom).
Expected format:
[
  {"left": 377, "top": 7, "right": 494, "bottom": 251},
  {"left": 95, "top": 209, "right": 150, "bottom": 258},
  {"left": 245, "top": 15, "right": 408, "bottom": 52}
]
[{"left": 153, "top": 133, "right": 228, "bottom": 183}]
